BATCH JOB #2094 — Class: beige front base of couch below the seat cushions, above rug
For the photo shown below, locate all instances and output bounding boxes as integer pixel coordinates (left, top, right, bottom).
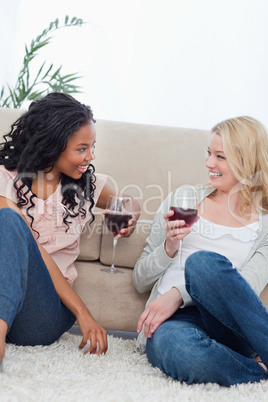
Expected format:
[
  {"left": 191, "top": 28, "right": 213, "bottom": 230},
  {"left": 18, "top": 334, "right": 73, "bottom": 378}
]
[{"left": 74, "top": 260, "right": 150, "bottom": 331}]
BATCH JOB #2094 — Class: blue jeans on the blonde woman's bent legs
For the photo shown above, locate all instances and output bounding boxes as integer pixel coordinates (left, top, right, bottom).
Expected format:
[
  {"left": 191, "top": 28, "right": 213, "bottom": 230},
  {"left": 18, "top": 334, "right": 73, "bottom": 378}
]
[{"left": 146, "top": 251, "right": 268, "bottom": 386}]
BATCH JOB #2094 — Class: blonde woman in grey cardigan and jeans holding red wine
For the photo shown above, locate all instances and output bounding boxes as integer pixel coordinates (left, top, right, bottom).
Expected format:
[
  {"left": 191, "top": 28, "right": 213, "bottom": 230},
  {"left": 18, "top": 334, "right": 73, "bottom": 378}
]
[{"left": 134, "top": 116, "right": 268, "bottom": 386}]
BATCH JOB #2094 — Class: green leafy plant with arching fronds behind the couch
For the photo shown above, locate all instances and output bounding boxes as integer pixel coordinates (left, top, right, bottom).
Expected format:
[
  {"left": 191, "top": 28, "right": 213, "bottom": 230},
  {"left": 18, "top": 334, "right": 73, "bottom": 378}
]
[{"left": 0, "top": 15, "right": 84, "bottom": 109}]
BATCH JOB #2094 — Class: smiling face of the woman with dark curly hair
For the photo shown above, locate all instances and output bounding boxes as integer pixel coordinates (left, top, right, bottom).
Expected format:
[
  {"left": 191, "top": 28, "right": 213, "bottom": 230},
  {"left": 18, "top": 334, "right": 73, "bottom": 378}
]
[{"left": 50, "top": 122, "right": 96, "bottom": 181}]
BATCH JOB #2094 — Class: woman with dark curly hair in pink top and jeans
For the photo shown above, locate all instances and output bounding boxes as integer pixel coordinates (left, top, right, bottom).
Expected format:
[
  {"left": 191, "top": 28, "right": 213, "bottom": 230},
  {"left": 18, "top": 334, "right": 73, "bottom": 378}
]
[{"left": 0, "top": 93, "right": 139, "bottom": 363}]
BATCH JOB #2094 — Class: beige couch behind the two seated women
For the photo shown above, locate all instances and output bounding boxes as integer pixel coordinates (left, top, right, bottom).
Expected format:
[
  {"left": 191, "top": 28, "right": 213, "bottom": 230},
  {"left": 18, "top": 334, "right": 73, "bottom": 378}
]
[{"left": 0, "top": 108, "right": 268, "bottom": 331}]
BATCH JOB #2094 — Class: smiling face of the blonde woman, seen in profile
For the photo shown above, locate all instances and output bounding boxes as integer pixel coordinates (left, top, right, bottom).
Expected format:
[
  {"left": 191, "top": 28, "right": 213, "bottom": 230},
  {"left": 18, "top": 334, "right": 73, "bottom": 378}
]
[{"left": 206, "top": 132, "right": 239, "bottom": 193}]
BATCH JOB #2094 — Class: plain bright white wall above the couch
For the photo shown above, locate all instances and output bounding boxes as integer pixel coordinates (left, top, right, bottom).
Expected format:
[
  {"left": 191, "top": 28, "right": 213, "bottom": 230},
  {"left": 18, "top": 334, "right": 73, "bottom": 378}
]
[{"left": 0, "top": 0, "right": 268, "bottom": 129}]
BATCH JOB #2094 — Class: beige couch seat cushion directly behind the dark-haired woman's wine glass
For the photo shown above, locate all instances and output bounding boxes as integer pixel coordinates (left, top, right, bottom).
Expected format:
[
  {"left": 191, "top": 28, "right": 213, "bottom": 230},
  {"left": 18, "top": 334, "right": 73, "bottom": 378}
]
[{"left": 100, "top": 220, "right": 152, "bottom": 268}]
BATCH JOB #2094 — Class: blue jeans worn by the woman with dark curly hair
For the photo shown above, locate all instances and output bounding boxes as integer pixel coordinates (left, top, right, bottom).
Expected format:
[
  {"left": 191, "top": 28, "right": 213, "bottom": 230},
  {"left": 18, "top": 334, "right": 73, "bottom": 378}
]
[{"left": 0, "top": 208, "right": 75, "bottom": 346}]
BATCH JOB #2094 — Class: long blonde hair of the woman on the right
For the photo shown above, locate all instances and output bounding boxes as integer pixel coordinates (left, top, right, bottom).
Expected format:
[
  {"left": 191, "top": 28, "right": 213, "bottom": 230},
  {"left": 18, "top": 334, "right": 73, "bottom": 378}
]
[{"left": 211, "top": 116, "right": 268, "bottom": 215}]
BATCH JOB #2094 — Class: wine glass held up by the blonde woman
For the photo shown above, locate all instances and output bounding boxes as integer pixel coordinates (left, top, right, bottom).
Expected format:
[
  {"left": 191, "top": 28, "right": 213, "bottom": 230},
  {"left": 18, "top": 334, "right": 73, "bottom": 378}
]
[{"left": 169, "top": 186, "right": 197, "bottom": 266}]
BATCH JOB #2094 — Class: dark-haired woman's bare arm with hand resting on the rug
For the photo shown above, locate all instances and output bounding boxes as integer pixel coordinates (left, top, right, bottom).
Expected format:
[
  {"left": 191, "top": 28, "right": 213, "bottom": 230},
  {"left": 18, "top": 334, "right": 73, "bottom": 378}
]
[{"left": 0, "top": 196, "right": 107, "bottom": 355}]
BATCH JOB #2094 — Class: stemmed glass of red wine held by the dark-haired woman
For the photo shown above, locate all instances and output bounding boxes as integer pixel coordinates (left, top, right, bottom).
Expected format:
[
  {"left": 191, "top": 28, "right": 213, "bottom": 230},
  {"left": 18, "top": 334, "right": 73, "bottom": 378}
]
[{"left": 101, "top": 195, "right": 132, "bottom": 274}]
